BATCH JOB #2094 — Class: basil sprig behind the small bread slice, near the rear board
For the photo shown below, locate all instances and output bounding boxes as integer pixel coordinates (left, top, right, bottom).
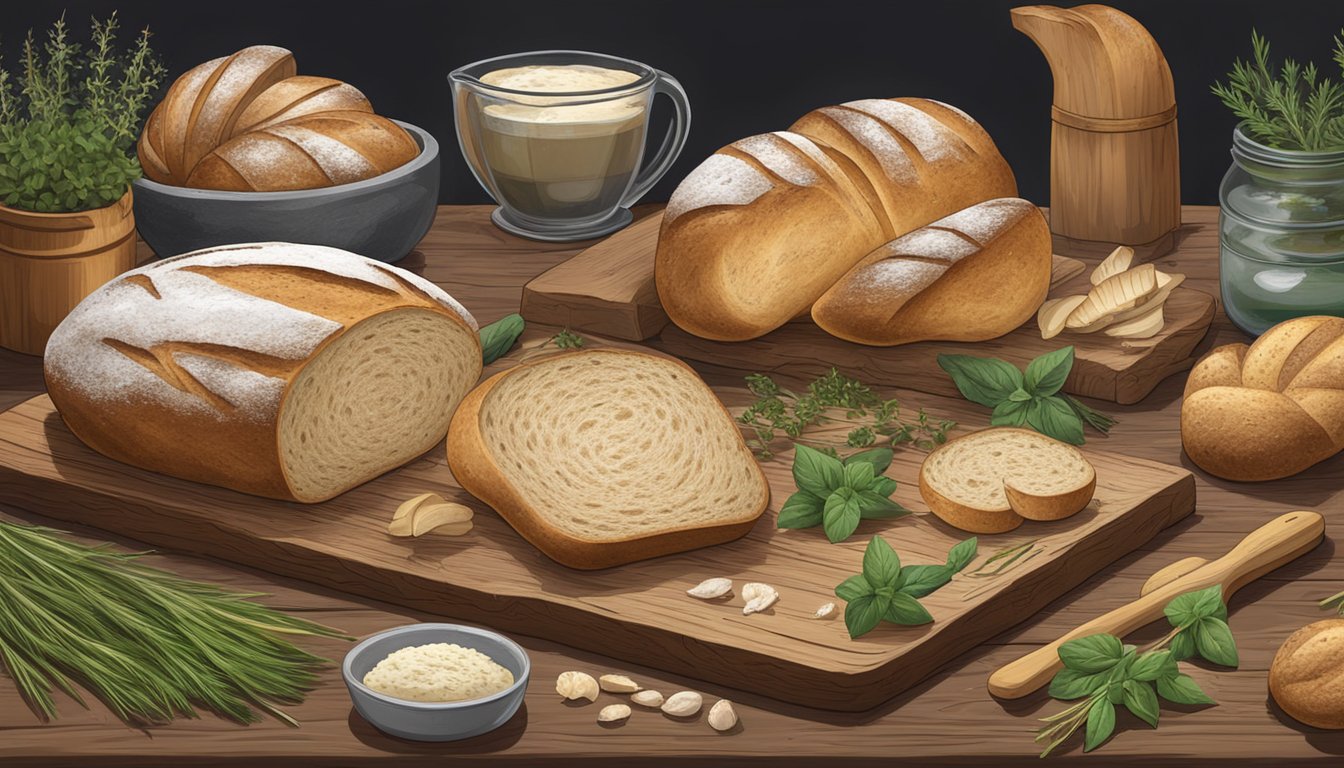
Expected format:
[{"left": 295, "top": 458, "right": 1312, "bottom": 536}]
[{"left": 938, "top": 347, "right": 1116, "bottom": 445}]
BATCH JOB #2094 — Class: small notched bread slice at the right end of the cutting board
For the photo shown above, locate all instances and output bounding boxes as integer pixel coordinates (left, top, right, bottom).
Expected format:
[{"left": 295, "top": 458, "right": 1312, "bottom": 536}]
[{"left": 919, "top": 426, "right": 1097, "bottom": 534}]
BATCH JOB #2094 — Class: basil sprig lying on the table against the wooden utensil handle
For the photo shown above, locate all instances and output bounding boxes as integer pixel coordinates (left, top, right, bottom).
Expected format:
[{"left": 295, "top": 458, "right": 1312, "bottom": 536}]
[{"left": 1036, "top": 585, "right": 1236, "bottom": 757}]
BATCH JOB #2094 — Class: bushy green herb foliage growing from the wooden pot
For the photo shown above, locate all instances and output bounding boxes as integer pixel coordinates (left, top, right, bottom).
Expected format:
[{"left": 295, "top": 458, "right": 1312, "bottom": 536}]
[{"left": 0, "top": 13, "right": 165, "bottom": 213}]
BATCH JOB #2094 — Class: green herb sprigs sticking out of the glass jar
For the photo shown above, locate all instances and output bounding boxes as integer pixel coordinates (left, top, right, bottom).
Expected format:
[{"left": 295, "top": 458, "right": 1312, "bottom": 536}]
[{"left": 1211, "top": 30, "right": 1344, "bottom": 152}]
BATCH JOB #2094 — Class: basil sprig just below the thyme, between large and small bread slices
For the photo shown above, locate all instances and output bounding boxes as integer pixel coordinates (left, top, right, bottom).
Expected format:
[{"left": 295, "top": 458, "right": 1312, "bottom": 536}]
[{"left": 775, "top": 444, "right": 910, "bottom": 543}]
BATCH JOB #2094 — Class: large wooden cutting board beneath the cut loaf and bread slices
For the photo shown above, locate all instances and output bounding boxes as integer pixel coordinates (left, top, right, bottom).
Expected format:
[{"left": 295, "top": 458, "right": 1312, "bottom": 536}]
[{"left": 0, "top": 389, "right": 1195, "bottom": 710}]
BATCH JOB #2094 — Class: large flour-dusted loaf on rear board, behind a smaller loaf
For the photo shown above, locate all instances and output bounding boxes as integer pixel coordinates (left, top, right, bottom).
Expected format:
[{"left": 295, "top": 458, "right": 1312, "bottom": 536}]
[{"left": 655, "top": 98, "right": 1017, "bottom": 340}]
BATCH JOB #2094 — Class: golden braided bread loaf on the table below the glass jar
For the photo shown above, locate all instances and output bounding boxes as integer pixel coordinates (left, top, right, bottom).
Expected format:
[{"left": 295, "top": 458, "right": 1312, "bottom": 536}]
[{"left": 1180, "top": 316, "right": 1344, "bottom": 480}]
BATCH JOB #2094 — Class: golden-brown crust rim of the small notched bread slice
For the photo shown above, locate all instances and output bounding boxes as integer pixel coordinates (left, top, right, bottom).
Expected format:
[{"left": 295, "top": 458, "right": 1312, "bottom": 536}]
[{"left": 919, "top": 426, "right": 1097, "bottom": 534}]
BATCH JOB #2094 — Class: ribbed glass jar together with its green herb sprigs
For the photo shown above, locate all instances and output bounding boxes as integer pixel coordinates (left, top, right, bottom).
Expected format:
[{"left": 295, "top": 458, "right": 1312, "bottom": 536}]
[{"left": 1212, "top": 32, "right": 1344, "bottom": 335}]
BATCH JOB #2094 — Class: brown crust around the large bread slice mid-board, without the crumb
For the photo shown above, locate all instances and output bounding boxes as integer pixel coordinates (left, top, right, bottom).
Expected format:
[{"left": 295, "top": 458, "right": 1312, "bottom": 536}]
[{"left": 448, "top": 348, "right": 770, "bottom": 570}]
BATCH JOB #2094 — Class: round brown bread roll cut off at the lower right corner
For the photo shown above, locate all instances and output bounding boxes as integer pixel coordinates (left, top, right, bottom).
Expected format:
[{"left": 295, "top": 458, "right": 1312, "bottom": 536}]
[{"left": 1269, "top": 619, "right": 1344, "bottom": 730}]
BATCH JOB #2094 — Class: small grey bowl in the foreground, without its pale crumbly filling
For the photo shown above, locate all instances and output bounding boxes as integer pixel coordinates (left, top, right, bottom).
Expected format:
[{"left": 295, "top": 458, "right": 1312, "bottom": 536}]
[{"left": 340, "top": 624, "right": 532, "bottom": 741}]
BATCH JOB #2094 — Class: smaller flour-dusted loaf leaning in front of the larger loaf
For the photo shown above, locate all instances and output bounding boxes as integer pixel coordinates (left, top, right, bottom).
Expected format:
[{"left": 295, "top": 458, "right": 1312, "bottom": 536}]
[{"left": 812, "top": 198, "right": 1051, "bottom": 347}]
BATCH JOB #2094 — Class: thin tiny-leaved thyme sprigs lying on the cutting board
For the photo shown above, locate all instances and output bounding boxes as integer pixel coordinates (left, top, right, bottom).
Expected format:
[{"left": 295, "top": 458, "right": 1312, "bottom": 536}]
[{"left": 738, "top": 369, "right": 957, "bottom": 459}]
